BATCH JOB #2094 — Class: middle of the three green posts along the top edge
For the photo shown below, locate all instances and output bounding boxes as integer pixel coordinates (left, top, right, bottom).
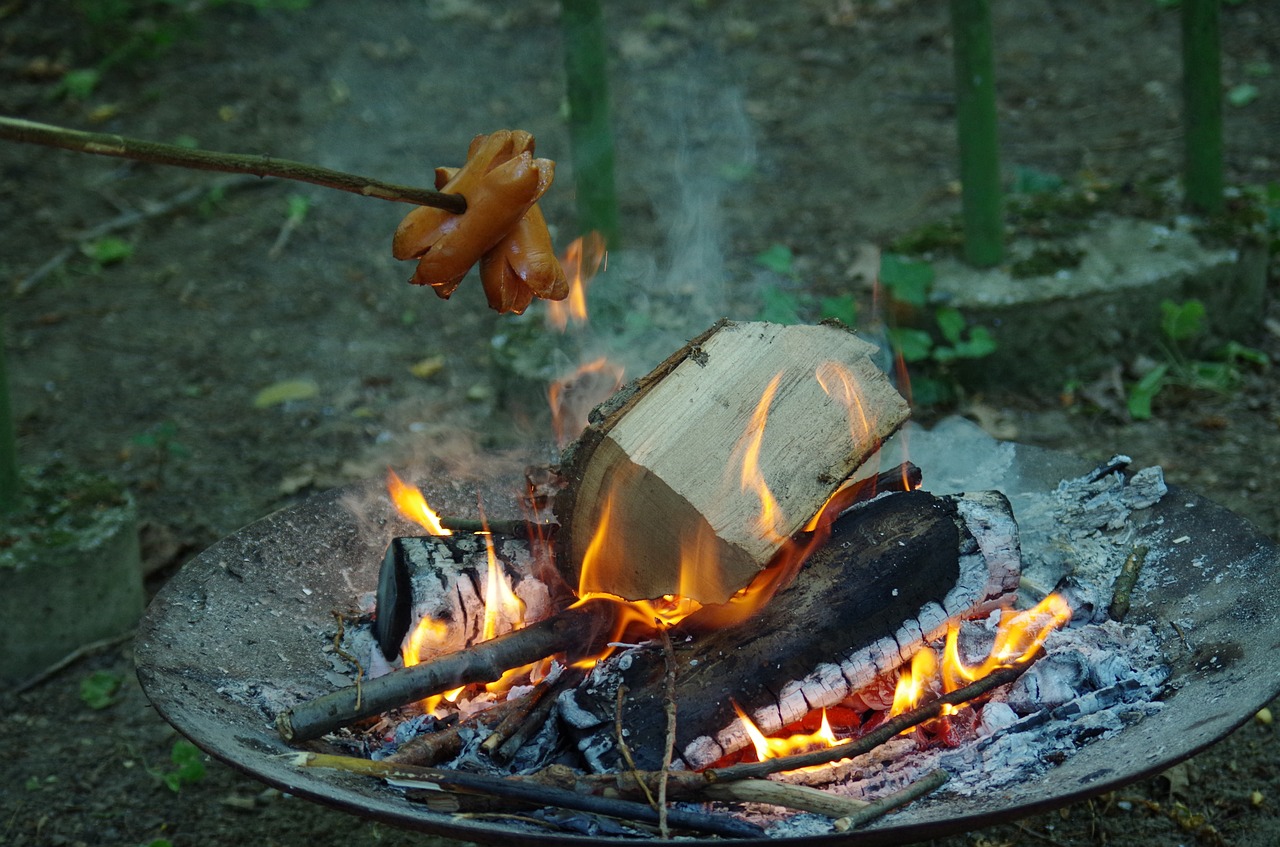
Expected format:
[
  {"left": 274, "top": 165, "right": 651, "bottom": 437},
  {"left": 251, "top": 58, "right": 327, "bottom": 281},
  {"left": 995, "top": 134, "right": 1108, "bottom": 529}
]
[{"left": 951, "top": 0, "right": 1005, "bottom": 267}]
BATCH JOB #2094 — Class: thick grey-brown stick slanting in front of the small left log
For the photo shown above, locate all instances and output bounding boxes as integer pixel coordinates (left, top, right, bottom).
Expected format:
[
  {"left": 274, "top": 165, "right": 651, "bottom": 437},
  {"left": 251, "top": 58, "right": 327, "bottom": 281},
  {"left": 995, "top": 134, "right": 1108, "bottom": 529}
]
[{"left": 275, "top": 600, "right": 625, "bottom": 741}]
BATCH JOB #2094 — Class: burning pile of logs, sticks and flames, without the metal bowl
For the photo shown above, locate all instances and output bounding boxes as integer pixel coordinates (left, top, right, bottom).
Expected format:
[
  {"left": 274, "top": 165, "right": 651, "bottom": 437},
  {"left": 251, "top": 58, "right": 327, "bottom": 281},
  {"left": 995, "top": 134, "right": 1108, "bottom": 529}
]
[{"left": 240, "top": 322, "right": 1165, "bottom": 837}]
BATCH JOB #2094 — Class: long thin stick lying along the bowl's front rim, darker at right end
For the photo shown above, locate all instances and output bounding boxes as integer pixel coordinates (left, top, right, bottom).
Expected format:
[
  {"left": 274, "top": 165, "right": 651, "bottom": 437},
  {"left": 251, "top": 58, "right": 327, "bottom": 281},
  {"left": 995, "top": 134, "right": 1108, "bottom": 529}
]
[{"left": 293, "top": 752, "right": 764, "bottom": 838}]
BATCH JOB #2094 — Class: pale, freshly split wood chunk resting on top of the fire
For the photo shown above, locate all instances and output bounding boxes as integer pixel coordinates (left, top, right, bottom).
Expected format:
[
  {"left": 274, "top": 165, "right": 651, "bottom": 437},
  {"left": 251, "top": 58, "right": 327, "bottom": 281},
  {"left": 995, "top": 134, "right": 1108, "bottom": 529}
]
[{"left": 556, "top": 321, "right": 910, "bottom": 604}]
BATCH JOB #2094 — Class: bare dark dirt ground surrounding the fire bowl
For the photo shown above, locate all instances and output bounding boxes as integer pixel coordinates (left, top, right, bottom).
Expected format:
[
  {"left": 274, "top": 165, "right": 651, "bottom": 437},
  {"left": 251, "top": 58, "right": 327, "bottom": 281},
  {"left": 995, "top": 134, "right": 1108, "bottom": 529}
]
[{"left": 0, "top": 0, "right": 1280, "bottom": 847}]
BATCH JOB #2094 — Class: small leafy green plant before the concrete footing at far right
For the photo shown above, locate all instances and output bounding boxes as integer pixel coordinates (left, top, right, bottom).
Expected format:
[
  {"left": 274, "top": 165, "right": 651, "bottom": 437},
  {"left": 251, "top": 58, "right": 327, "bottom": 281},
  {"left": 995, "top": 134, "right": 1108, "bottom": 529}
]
[{"left": 1128, "top": 299, "right": 1271, "bottom": 421}]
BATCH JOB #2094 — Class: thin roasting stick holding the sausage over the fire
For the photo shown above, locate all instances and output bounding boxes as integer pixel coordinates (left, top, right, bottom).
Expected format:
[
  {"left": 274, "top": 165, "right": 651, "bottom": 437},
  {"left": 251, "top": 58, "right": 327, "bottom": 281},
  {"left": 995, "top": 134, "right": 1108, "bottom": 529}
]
[{"left": 0, "top": 116, "right": 467, "bottom": 215}]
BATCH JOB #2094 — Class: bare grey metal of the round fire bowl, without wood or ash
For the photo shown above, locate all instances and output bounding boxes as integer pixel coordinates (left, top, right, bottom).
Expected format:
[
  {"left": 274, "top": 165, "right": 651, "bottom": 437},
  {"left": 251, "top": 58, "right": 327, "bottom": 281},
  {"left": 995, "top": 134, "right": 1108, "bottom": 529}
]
[{"left": 137, "top": 447, "right": 1280, "bottom": 846}]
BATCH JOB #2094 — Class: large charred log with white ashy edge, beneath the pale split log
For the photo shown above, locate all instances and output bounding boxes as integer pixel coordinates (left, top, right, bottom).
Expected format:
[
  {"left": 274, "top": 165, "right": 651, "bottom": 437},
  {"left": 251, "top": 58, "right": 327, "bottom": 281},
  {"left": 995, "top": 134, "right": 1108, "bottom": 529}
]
[{"left": 561, "top": 491, "right": 1020, "bottom": 772}]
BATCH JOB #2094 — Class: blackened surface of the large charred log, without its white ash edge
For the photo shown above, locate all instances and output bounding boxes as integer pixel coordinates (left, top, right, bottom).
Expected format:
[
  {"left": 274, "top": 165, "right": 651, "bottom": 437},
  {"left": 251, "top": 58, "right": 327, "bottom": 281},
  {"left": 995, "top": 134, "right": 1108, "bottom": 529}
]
[{"left": 562, "top": 491, "right": 961, "bottom": 770}]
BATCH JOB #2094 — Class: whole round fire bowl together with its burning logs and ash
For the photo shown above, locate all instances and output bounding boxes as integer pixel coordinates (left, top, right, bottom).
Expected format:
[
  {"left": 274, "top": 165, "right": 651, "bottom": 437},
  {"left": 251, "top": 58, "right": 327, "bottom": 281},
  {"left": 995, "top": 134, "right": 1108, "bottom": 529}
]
[{"left": 140, "top": 322, "right": 1275, "bottom": 841}]
